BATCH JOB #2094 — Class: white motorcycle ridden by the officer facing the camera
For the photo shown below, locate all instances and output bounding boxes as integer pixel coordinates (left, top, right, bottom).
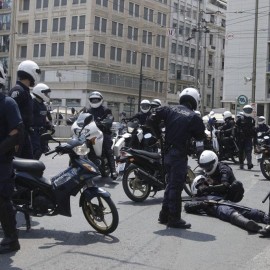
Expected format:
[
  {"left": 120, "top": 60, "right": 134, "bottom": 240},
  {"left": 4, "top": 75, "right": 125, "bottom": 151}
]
[{"left": 71, "top": 113, "right": 114, "bottom": 177}]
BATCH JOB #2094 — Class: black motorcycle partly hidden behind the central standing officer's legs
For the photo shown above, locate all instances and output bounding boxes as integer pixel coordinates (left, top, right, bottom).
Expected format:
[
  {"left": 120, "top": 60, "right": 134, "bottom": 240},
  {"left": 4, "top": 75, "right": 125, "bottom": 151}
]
[{"left": 119, "top": 144, "right": 195, "bottom": 202}]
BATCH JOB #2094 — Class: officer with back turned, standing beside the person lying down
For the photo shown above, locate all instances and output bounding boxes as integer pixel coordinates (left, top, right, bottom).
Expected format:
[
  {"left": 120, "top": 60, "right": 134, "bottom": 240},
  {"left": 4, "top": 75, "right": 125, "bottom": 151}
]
[{"left": 148, "top": 88, "right": 205, "bottom": 228}]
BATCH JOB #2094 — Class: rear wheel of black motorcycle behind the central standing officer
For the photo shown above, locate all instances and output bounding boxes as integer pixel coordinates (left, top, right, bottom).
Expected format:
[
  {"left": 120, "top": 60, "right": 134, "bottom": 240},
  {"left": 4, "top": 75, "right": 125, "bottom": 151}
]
[{"left": 122, "top": 164, "right": 151, "bottom": 202}]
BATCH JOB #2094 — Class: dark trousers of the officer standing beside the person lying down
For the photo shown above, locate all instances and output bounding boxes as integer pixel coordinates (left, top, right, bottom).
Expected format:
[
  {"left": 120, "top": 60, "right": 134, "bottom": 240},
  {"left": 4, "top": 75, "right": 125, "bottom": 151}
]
[{"left": 163, "top": 148, "right": 187, "bottom": 214}]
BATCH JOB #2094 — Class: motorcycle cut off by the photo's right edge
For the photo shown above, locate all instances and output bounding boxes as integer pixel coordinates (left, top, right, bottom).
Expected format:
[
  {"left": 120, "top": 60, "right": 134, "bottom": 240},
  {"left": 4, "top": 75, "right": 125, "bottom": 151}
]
[{"left": 255, "top": 132, "right": 270, "bottom": 180}]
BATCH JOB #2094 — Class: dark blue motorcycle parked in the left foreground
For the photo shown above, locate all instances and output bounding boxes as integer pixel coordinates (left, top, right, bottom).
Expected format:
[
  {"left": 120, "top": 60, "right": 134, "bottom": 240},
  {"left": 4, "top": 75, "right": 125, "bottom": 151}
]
[{"left": 12, "top": 116, "right": 119, "bottom": 234}]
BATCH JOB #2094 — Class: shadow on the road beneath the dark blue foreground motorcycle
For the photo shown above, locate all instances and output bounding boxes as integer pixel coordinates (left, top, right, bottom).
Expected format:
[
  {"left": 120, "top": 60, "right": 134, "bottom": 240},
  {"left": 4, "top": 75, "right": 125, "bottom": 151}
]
[{"left": 19, "top": 229, "right": 119, "bottom": 249}]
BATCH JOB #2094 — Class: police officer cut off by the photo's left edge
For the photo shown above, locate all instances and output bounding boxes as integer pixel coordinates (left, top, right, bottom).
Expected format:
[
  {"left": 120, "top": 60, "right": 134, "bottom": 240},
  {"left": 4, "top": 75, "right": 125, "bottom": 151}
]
[{"left": 0, "top": 65, "right": 23, "bottom": 254}]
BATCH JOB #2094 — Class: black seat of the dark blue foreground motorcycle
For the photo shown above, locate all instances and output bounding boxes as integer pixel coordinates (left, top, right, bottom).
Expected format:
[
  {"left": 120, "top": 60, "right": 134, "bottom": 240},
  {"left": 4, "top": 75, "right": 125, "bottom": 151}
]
[{"left": 13, "top": 158, "right": 45, "bottom": 173}]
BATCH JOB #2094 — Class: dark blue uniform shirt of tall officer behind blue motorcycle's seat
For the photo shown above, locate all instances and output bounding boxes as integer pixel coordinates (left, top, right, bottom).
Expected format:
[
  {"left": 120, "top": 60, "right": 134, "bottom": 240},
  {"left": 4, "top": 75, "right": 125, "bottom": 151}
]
[{"left": 8, "top": 81, "right": 33, "bottom": 130}]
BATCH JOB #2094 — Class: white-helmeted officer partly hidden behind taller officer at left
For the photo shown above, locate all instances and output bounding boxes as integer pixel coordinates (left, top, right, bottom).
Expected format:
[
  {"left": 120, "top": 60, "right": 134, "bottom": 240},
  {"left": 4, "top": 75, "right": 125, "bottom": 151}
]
[{"left": 30, "top": 83, "right": 52, "bottom": 160}]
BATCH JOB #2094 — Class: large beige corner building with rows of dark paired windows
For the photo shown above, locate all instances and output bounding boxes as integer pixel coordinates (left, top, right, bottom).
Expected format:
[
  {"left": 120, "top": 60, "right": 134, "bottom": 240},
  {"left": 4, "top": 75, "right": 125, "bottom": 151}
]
[{"left": 11, "top": 0, "right": 169, "bottom": 119}]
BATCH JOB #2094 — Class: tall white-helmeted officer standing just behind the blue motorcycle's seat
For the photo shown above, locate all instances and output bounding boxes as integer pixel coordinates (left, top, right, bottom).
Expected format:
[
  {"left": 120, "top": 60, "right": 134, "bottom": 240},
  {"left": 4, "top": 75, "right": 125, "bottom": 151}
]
[{"left": 9, "top": 60, "right": 41, "bottom": 159}]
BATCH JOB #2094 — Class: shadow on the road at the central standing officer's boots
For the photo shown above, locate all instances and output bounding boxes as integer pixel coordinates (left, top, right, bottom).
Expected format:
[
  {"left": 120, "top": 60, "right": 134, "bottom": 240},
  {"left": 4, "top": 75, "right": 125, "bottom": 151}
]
[{"left": 154, "top": 227, "right": 216, "bottom": 242}]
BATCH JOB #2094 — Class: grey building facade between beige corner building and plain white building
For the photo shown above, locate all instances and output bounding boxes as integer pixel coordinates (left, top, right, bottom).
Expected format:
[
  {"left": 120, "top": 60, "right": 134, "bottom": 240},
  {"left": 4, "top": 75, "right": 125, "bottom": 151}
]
[{"left": 167, "top": 0, "right": 227, "bottom": 113}]
